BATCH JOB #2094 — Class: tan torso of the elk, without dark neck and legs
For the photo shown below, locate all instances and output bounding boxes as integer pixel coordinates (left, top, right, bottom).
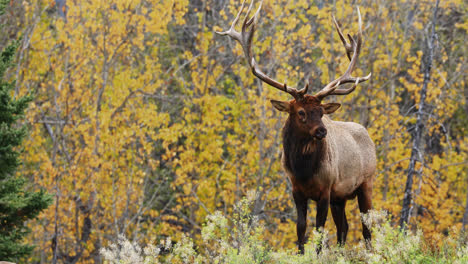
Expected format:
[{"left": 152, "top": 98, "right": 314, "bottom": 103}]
[{"left": 282, "top": 115, "right": 376, "bottom": 201}]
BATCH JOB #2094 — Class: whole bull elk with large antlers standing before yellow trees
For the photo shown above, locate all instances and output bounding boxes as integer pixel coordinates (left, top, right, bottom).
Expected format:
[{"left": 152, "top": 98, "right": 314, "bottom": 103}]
[{"left": 216, "top": 0, "right": 376, "bottom": 254}]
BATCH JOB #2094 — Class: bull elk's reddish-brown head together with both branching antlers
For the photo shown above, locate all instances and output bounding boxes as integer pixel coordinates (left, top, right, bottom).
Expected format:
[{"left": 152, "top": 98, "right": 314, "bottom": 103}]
[{"left": 216, "top": 0, "right": 371, "bottom": 139}]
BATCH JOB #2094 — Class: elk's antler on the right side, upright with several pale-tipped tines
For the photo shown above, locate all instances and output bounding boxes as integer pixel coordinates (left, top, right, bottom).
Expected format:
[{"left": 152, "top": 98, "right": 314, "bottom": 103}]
[{"left": 315, "top": 8, "right": 371, "bottom": 100}]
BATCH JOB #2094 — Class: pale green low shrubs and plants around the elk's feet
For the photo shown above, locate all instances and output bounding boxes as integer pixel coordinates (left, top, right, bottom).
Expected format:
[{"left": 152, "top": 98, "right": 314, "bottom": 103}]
[{"left": 100, "top": 195, "right": 468, "bottom": 264}]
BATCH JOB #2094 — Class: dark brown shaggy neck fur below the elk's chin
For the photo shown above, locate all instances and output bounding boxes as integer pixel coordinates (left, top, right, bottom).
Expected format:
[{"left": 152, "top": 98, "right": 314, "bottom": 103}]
[{"left": 283, "top": 119, "right": 326, "bottom": 181}]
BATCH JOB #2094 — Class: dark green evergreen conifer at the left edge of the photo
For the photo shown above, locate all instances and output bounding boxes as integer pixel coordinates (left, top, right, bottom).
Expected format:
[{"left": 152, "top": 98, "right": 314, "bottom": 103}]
[{"left": 0, "top": 1, "right": 52, "bottom": 261}]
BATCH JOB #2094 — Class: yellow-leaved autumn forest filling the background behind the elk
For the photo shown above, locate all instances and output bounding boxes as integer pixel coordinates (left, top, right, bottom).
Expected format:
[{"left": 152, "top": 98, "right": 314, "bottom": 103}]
[{"left": 0, "top": 0, "right": 468, "bottom": 263}]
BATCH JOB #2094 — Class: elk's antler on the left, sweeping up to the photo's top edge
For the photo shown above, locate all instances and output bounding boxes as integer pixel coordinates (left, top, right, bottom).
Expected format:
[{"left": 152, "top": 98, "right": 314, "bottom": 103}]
[{"left": 216, "top": 0, "right": 309, "bottom": 100}]
